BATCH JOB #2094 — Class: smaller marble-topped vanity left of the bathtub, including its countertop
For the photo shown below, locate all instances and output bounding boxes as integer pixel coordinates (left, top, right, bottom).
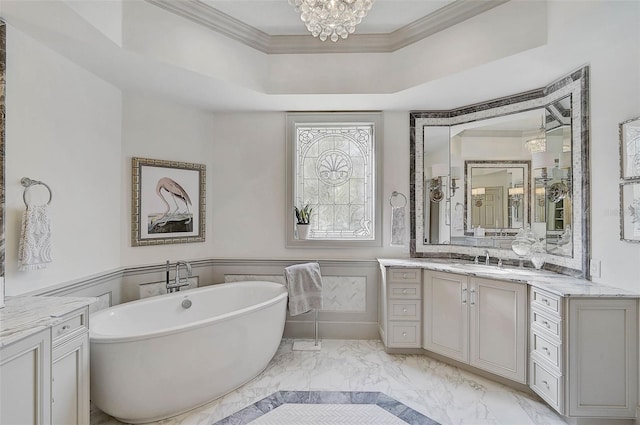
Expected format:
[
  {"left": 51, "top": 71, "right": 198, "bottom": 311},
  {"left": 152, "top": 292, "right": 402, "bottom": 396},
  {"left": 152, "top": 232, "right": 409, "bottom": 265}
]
[{"left": 0, "top": 297, "right": 95, "bottom": 425}]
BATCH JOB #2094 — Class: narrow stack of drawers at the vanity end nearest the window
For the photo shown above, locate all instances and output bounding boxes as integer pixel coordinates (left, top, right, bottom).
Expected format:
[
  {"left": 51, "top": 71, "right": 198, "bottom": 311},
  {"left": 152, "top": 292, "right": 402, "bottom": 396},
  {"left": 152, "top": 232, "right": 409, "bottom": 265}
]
[{"left": 384, "top": 268, "right": 422, "bottom": 348}]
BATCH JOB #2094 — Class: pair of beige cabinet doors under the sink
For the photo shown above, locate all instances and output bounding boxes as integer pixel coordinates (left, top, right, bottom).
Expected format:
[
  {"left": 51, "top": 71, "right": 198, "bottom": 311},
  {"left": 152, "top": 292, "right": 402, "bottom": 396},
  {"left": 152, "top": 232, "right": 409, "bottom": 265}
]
[{"left": 423, "top": 271, "right": 527, "bottom": 383}]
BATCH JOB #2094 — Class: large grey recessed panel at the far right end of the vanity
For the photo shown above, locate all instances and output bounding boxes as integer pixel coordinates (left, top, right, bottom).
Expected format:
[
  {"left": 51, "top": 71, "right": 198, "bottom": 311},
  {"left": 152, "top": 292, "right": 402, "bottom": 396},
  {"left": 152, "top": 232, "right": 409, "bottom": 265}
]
[{"left": 568, "top": 299, "right": 638, "bottom": 418}]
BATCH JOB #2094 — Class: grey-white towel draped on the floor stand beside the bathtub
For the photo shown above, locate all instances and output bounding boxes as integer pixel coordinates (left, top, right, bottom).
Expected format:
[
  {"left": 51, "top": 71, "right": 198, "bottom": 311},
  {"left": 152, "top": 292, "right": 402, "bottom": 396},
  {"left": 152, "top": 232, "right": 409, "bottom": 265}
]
[{"left": 284, "top": 263, "right": 322, "bottom": 316}]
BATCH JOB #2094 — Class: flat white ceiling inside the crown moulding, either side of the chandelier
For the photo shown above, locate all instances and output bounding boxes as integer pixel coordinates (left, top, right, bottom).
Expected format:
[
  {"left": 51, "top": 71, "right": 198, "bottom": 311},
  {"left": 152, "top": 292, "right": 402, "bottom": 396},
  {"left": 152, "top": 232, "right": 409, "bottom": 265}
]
[{"left": 201, "top": 0, "right": 454, "bottom": 35}]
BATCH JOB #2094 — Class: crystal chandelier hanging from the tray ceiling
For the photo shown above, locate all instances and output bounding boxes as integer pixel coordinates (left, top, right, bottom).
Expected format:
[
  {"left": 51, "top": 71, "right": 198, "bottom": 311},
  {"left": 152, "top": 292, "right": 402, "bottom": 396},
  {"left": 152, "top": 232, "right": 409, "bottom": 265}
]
[{"left": 289, "top": 0, "right": 374, "bottom": 42}]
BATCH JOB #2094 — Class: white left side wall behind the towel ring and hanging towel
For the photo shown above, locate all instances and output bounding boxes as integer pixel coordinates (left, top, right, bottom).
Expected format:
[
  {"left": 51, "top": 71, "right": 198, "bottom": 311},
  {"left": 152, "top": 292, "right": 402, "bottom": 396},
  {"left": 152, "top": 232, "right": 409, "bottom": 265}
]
[{"left": 5, "top": 25, "right": 122, "bottom": 295}]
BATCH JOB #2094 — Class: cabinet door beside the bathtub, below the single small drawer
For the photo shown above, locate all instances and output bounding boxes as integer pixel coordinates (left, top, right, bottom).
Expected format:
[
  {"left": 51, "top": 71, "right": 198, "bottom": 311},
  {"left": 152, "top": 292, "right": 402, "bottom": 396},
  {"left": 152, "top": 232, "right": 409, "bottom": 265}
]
[{"left": 51, "top": 333, "right": 89, "bottom": 425}]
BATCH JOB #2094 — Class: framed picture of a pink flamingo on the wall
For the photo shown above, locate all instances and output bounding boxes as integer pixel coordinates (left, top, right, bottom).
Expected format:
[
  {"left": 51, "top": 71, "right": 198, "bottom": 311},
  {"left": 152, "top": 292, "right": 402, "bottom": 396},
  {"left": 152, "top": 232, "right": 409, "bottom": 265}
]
[{"left": 131, "top": 158, "right": 206, "bottom": 246}]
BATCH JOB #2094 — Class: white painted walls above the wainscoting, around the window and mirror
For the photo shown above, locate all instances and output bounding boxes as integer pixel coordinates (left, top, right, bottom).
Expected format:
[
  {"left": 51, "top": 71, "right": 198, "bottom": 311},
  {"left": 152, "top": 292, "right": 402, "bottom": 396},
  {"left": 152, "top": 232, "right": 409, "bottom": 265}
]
[{"left": 1, "top": 1, "right": 640, "bottom": 294}]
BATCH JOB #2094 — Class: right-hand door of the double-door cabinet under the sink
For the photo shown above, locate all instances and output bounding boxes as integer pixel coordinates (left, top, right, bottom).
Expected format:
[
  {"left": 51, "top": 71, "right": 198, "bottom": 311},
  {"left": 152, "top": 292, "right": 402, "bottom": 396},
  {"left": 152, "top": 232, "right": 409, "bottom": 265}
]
[{"left": 469, "top": 278, "right": 527, "bottom": 383}]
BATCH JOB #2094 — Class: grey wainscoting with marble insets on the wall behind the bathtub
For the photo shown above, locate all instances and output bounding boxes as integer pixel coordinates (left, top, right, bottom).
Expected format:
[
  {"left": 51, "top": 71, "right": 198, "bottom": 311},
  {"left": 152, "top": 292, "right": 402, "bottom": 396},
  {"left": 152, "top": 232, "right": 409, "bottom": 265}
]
[{"left": 33, "top": 259, "right": 380, "bottom": 339}]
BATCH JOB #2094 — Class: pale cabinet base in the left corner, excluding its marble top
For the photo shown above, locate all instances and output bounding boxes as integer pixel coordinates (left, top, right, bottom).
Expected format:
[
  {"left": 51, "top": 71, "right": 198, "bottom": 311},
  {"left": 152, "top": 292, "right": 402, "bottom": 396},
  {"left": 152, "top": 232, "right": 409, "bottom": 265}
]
[{"left": 0, "top": 307, "right": 89, "bottom": 425}]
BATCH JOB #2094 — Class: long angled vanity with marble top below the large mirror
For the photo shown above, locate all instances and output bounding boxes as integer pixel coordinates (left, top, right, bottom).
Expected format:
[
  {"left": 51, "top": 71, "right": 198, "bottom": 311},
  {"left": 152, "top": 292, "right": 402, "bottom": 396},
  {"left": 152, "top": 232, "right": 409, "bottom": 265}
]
[{"left": 378, "top": 258, "right": 640, "bottom": 423}]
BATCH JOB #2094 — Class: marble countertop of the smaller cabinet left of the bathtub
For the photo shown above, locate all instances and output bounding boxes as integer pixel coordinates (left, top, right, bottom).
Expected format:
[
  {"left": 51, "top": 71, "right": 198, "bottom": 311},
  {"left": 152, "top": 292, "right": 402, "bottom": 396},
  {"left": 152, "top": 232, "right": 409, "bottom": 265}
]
[{"left": 0, "top": 296, "right": 97, "bottom": 347}]
